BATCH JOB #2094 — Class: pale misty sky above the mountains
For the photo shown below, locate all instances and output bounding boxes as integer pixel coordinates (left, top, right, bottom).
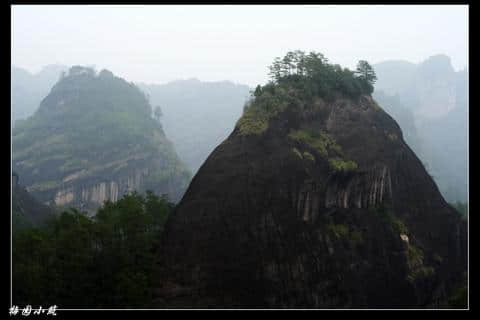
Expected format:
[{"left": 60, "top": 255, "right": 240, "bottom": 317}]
[{"left": 12, "top": 5, "right": 468, "bottom": 86}]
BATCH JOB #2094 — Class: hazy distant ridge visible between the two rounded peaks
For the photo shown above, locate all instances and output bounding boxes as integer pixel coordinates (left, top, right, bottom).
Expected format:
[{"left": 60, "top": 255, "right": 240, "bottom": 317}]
[{"left": 138, "top": 78, "right": 250, "bottom": 173}]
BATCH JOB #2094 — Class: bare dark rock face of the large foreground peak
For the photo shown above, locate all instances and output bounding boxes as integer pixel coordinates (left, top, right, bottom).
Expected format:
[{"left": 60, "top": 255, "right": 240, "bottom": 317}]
[{"left": 157, "top": 96, "right": 467, "bottom": 308}]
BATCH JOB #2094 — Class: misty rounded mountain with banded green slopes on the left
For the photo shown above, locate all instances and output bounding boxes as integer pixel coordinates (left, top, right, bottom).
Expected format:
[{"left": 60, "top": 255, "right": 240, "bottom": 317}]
[{"left": 12, "top": 66, "right": 190, "bottom": 211}]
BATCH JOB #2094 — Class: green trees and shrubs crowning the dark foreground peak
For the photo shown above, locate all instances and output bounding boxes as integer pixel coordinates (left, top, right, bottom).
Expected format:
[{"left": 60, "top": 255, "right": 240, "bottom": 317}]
[{"left": 236, "top": 50, "right": 376, "bottom": 135}]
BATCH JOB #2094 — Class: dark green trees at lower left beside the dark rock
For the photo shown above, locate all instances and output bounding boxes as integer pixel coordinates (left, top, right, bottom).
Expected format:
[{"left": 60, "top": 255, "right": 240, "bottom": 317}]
[{"left": 12, "top": 192, "right": 173, "bottom": 308}]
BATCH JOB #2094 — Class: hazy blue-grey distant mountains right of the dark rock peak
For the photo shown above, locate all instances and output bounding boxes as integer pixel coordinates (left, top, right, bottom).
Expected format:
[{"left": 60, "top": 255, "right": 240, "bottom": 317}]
[{"left": 373, "top": 55, "right": 468, "bottom": 202}]
